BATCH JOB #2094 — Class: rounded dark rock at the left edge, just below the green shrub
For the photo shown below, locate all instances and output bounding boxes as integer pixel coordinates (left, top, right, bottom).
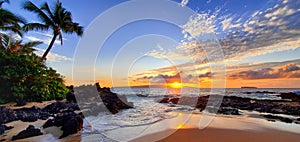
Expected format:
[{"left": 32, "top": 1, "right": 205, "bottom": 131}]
[{"left": 0, "top": 106, "right": 17, "bottom": 124}]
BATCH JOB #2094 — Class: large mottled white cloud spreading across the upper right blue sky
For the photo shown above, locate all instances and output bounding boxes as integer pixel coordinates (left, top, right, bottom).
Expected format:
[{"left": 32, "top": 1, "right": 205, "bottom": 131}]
[{"left": 164, "top": 0, "right": 300, "bottom": 61}]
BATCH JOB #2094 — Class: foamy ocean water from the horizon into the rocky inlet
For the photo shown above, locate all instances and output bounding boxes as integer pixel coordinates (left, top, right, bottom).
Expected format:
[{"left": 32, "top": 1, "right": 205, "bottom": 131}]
[{"left": 82, "top": 88, "right": 300, "bottom": 134}]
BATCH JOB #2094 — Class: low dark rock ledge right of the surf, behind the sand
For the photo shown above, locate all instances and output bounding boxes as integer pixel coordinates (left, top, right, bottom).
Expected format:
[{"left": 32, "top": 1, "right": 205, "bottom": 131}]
[{"left": 159, "top": 92, "right": 300, "bottom": 124}]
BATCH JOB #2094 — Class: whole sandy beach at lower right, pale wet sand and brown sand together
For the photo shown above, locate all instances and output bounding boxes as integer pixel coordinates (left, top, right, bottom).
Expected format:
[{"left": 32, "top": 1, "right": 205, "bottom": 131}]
[{"left": 83, "top": 113, "right": 300, "bottom": 142}]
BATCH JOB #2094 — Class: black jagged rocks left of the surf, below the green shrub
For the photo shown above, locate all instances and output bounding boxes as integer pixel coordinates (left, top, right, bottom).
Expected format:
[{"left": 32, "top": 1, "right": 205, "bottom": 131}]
[{"left": 0, "top": 84, "right": 133, "bottom": 141}]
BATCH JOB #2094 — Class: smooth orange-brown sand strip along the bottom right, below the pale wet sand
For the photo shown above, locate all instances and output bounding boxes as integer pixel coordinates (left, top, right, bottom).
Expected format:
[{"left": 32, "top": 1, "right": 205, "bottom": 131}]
[{"left": 131, "top": 128, "right": 300, "bottom": 142}]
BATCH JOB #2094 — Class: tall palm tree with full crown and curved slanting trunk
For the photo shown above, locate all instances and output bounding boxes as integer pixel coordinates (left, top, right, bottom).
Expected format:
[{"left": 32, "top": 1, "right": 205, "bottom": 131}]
[{"left": 23, "top": 0, "right": 83, "bottom": 59}]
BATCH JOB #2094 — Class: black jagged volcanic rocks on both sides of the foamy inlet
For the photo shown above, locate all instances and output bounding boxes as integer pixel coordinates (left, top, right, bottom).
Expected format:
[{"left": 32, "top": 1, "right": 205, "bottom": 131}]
[{"left": 0, "top": 86, "right": 300, "bottom": 141}]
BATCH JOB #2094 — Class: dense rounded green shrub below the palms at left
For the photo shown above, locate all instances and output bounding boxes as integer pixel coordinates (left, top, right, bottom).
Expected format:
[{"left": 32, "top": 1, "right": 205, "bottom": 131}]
[{"left": 0, "top": 50, "right": 68, "bottom": 105}]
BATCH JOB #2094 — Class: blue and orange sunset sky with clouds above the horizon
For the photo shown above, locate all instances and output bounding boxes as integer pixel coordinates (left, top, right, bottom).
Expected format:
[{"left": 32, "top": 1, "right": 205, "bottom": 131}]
[{"left": 3, "top": 0, "right": 300, "bottom": 88}]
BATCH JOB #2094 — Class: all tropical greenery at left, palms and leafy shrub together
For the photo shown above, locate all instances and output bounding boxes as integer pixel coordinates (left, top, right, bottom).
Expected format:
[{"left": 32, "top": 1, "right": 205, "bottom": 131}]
[{"left": 0, "top": 0, "right": 78, "bottom": 105}]
